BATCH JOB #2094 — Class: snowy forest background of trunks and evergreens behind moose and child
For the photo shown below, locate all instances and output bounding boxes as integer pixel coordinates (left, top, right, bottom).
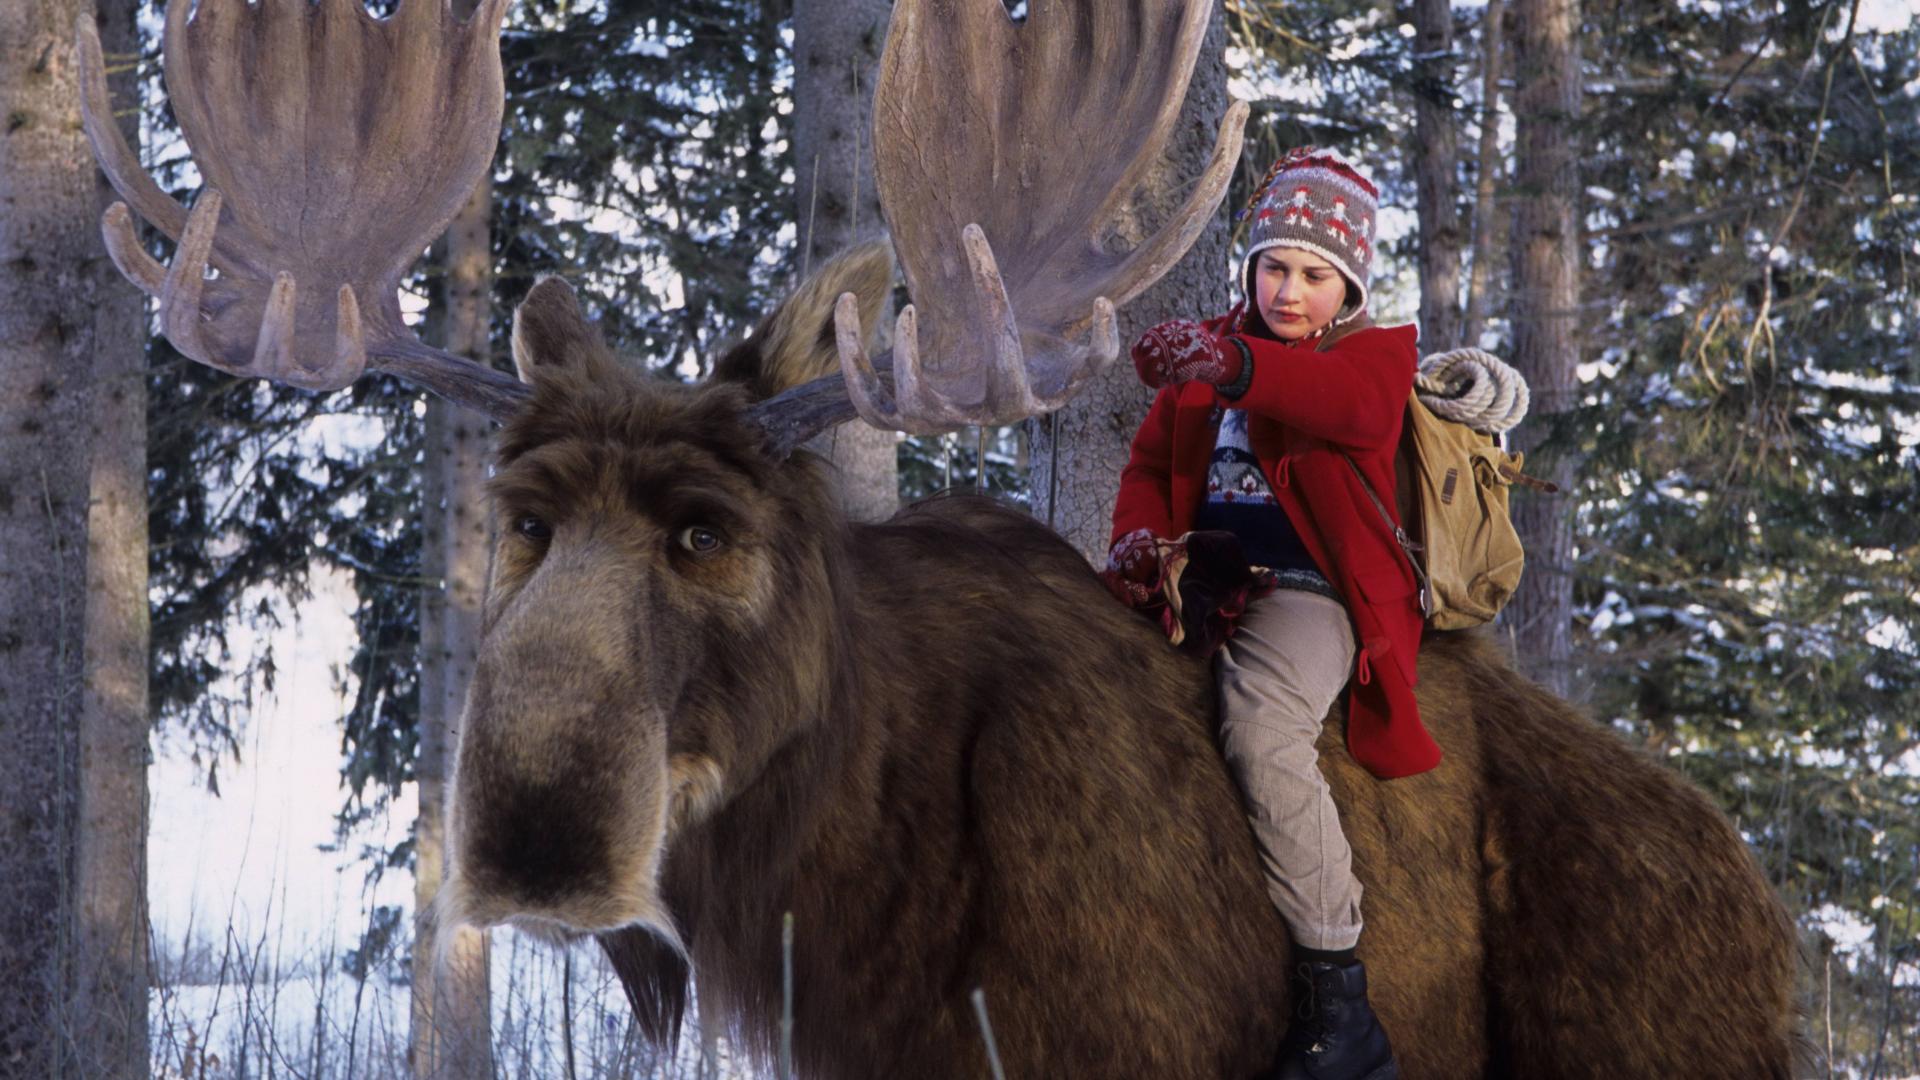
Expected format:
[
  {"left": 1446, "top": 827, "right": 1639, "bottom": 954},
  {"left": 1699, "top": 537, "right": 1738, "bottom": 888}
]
[{"left": 0, "top": 0, "right": 1920, "bottom": 1076}]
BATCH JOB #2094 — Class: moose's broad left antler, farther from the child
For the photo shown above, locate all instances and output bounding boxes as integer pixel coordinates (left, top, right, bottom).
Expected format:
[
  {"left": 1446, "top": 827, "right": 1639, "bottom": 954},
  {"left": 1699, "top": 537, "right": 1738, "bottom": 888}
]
[{"left": 79, "top": 0, "right": 526, "bottom": 415}]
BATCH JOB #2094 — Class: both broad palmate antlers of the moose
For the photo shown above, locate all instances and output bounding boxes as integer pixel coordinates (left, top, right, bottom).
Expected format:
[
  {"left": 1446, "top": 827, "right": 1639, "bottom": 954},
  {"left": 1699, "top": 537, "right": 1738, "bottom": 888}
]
[{"left": 79, "top": 0, "right": 1246, "bottom": 443}]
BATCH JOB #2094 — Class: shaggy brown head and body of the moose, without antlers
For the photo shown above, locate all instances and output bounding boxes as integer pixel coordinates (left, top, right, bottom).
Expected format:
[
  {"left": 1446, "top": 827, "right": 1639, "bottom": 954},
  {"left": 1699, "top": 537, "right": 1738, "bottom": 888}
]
[{"left": 445, "top": 255, "right": 1793, "bottom": 1080}]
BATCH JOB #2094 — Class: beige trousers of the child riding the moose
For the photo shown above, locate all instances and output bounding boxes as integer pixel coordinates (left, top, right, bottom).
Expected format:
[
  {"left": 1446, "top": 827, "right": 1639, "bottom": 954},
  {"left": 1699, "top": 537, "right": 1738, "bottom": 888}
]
[{"left": 1213, "top": 588, "right": 1359, "bottom": 949}]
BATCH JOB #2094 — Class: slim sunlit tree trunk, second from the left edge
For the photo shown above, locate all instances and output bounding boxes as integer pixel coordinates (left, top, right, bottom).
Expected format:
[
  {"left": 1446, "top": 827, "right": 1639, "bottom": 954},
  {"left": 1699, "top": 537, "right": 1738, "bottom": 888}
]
[{"left": 67, "top": 0, "right": 148, "bottom": 1080}]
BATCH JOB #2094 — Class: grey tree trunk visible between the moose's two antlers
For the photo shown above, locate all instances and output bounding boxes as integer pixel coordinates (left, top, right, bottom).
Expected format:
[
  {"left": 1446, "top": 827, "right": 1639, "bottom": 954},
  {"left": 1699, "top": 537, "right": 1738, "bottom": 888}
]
[{"left": 793, "top": 0, "right": 900, "bottom": 521}]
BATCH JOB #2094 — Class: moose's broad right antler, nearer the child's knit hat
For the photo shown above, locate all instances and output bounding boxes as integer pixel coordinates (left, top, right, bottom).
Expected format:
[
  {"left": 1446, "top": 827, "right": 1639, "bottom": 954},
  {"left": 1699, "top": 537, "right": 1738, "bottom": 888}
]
[{"left": 821, "top": 0, "right": 1246, "bottom": 432}]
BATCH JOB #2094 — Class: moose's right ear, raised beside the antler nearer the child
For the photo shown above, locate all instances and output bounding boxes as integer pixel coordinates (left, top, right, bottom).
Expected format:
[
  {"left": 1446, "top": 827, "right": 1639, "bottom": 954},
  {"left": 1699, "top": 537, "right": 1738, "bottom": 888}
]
[{"left": 712, "top": 240, "right": 893, "bottom": 398}]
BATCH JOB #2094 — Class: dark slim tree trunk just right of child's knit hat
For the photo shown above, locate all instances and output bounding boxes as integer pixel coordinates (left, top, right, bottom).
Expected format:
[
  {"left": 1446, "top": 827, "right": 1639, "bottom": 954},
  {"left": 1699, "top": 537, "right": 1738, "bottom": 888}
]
[{"left": 1413, "top": 0, "right": 1463, "bottom": 352}]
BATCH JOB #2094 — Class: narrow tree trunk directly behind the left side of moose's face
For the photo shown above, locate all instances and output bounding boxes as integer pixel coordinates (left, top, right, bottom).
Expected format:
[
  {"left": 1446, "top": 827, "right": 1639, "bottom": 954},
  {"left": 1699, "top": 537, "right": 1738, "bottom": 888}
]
[{"left": 411, "top": 177, "right": 493, "bottom": 1080}]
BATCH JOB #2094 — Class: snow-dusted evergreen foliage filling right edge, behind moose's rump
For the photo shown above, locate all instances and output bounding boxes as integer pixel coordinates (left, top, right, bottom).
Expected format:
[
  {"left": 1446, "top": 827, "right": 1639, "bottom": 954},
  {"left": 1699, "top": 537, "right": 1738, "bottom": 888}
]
[{"left": 1574, "top": 4, "right": 1920, "bottom": 1074}]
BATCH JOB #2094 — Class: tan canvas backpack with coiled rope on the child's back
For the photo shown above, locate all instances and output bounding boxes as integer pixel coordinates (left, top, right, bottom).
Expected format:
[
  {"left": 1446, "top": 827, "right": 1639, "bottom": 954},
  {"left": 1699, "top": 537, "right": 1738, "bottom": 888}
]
[{"left": 1319, "top": 323, "right": 1557, "bottom": 630}]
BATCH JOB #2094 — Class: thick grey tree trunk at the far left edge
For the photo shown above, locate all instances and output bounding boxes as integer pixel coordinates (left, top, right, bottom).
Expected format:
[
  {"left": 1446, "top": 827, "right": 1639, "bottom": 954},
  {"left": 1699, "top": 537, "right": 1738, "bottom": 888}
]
[{"left": 0, "top": 0, "right": 135, "bottom": 1076}]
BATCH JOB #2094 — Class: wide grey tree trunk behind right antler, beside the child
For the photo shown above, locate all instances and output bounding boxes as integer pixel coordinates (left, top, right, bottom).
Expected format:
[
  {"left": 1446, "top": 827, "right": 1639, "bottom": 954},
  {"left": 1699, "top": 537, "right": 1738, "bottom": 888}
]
[{"left": 1027, "top": 6, "right": 1228, "bottom": 565}]
